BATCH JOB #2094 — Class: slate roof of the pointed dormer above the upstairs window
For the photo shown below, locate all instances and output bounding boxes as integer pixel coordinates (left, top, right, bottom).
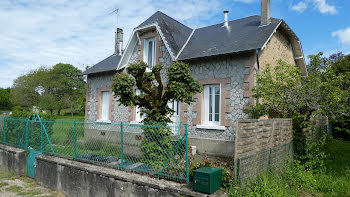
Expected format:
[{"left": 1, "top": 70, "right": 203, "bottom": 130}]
[{"left": 136, "top": 11, "right": 193, "bottom": 56}]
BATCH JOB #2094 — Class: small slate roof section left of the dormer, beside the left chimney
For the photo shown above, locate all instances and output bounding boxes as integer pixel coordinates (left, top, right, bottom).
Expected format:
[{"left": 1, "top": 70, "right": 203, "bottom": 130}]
[{"left": 83, "top": 54, "right": 121, "bottom": 75}]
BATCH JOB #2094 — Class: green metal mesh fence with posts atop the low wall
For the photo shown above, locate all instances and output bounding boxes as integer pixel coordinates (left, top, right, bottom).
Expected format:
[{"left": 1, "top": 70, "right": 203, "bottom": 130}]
[{"left": 0, "top": 117, "right": 189, "bottom": 183}]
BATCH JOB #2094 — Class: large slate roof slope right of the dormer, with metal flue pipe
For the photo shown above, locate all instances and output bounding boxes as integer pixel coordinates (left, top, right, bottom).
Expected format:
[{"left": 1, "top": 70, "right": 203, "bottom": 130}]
[{"left": 177, "top": 16, "right": 282, "bottom": 60}]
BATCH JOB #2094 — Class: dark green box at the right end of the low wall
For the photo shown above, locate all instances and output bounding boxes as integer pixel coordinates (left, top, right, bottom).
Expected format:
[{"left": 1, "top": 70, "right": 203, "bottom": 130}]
[{"left": 193, "top": 167, "right": 222, "bottom": 194}]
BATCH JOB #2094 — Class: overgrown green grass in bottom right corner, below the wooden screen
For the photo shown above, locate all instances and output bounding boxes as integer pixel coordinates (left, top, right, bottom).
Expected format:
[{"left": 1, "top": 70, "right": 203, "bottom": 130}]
[{"left": 229, "top": 139, "right": 350, "bottom": 197}]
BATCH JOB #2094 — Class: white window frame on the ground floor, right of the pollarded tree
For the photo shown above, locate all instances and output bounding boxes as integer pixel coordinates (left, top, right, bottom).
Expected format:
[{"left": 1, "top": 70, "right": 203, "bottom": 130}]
[{"left": 204, "top": 84, "right": 222, "bottom": 126}]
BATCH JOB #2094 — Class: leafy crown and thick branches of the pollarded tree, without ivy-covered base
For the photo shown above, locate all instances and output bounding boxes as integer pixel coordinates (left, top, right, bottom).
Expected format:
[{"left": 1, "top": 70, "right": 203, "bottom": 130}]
[{"left": 112, "top": 62, "right": 202, "bottom": 123}]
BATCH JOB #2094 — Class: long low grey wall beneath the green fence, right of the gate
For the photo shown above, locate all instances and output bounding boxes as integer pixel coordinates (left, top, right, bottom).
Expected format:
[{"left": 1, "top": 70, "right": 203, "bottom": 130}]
[{"left": 35, "top": 155, "right": 213, "bottom": 197}]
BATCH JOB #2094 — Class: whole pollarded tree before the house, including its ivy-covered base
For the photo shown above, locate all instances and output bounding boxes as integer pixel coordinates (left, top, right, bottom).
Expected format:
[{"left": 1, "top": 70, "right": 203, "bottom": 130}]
[{"left": 112, "top": 62, "right": 202, "bottom": 168}]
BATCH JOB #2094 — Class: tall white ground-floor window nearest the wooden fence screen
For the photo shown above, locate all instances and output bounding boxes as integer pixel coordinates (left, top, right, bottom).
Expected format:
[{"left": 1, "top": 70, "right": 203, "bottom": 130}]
[{"left": 204, "top": 85, "right": 220, "bottom": 125}]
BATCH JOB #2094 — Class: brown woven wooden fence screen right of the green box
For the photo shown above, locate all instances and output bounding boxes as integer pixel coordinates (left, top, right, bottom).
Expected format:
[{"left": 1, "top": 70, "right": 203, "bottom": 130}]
[{"left": 234, "top": 119, "right": 293, "bottom": 185}]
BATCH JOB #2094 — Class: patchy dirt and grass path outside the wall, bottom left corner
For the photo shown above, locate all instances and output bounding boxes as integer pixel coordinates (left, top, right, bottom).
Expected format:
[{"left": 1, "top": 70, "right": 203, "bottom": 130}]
[{"left": 0, "top": 171, "right": 65, "bottom": 197}]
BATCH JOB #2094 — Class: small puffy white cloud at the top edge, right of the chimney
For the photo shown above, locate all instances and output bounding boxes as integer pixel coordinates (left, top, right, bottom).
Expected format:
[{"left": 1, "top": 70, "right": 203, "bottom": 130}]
[{"left": 291, "top": 0, "right": 338, "bottom": 14}]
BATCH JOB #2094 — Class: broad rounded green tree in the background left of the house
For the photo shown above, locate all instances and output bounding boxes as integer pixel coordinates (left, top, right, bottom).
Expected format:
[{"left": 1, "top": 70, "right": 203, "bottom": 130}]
[{"left": 11, "top": 63, "right": 85, "bottom": 114}]
